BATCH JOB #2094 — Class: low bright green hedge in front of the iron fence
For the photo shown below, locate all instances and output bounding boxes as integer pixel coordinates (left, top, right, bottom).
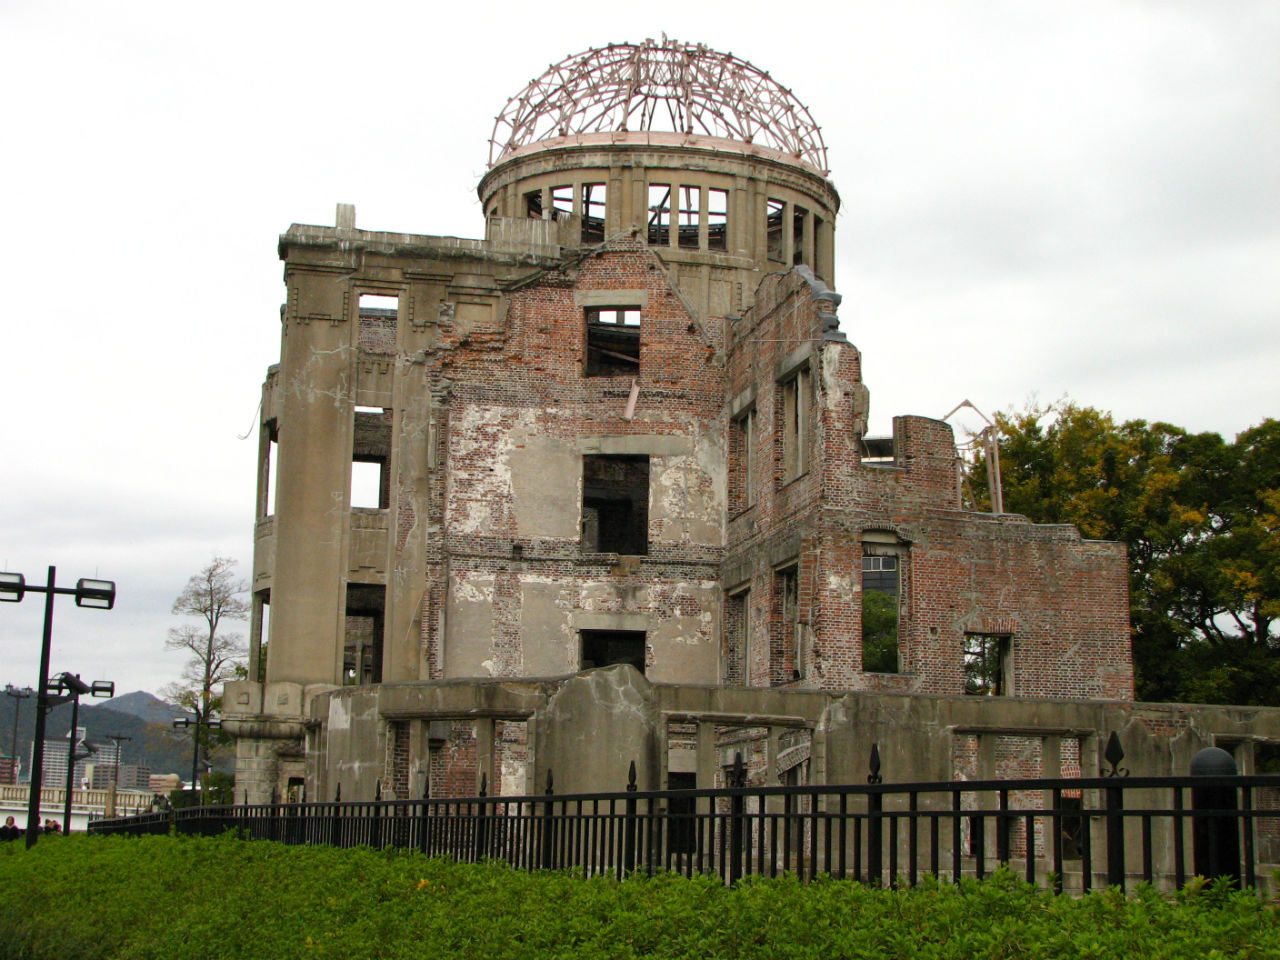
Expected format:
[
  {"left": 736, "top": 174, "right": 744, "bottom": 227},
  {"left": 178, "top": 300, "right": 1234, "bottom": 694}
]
[{"left": 0, "top": 836, "right": 1280, "bottom": 960}]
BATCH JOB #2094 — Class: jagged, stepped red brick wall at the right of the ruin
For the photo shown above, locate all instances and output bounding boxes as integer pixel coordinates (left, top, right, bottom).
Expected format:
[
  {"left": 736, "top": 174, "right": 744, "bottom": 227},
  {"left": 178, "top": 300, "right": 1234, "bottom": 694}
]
[{"left": 726, "top": 268, "right": 1133, "bottom": 699}]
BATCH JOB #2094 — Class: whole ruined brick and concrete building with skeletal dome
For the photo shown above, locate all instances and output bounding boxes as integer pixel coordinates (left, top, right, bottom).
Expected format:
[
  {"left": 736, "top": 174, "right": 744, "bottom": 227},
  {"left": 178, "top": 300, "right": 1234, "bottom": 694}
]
[{"left": 224, "top": 41, "right": 1280, "bottom": 801}]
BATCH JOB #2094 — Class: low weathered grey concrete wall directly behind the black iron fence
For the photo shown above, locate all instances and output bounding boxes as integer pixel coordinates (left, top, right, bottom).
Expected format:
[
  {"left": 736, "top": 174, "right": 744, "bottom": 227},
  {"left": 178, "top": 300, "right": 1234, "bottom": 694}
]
[{"left": 307, "top": 666, "right": 1280, "bottom": 799}]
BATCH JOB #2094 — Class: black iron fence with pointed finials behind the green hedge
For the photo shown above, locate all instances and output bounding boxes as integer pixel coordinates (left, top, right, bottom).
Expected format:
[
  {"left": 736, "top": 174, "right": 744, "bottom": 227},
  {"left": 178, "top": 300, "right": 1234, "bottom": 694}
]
[{"left": 90, "top": 762, "right": 1280, "bottom": 892}]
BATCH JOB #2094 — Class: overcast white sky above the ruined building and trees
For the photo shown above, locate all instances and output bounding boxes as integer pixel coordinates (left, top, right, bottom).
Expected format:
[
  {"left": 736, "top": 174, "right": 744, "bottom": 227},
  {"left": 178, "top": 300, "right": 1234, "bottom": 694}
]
[{"left": 0, "top": 0, "right": 1280, "bottom": 692}]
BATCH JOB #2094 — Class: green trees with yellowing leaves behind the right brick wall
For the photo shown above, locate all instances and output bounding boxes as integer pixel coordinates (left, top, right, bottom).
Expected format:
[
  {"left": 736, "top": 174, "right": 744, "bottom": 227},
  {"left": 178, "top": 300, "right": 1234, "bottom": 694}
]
[{"left": 973, "top": 402, "right": 1280, "bottom": 704}]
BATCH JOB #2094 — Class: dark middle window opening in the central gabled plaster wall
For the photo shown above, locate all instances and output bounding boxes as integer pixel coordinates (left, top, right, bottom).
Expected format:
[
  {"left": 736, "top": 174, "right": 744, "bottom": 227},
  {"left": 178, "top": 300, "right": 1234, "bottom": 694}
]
[{"left": 582, "top": 454, "right": 649, "bottom": 557}]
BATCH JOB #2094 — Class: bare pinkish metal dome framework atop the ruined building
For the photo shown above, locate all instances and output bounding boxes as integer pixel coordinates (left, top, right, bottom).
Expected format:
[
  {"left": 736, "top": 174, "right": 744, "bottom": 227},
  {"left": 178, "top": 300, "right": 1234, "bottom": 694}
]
[{"left": 489, "top": 36, "right": 828, "bottom": 175}]
